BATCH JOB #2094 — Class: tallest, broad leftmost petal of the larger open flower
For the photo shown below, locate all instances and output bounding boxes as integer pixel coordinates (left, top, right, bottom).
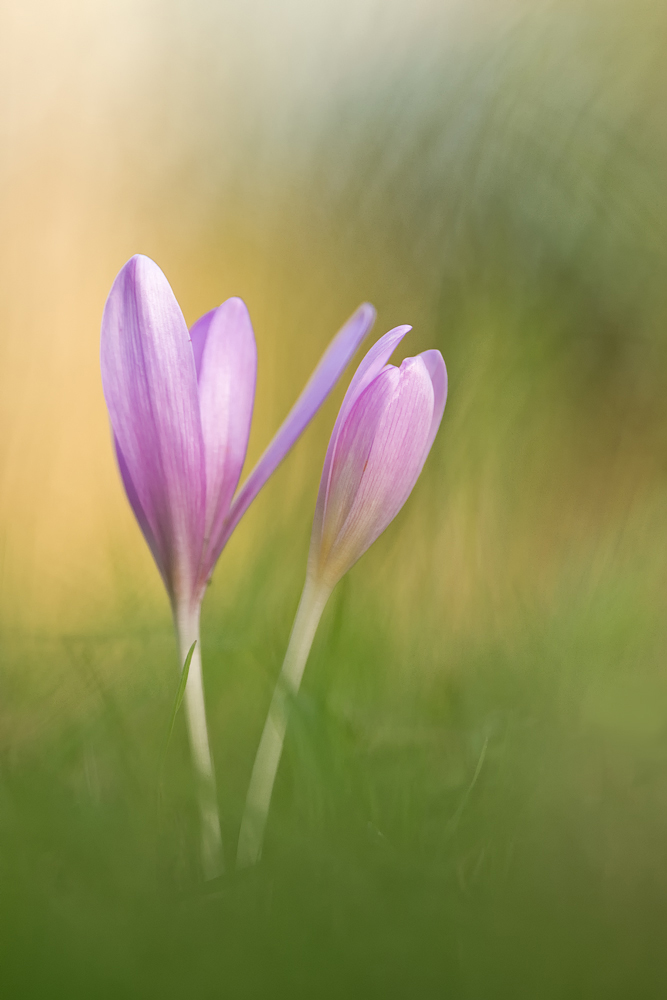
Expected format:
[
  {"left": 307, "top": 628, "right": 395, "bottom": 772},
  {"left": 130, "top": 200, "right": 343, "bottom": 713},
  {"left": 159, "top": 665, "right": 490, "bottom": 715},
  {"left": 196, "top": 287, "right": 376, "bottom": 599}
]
[{"left": 101, "top": 256, "right": 206, "bottom": 602}]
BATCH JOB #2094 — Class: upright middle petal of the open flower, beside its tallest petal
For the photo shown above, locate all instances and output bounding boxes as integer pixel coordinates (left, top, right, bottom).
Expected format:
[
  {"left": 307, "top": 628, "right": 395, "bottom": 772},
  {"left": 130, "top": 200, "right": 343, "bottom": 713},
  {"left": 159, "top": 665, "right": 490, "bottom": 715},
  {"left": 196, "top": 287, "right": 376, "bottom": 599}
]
[{"left": 196, "top": 298, "right": 257, "bottom": 580}]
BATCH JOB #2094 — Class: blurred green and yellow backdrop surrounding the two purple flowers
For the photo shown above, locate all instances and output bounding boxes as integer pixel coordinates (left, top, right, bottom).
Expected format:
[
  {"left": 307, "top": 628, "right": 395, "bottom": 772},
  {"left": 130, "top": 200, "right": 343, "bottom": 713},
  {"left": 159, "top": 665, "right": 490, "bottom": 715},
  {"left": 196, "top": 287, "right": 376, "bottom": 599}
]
[{"left": 0, "top": 0, "right": 667, "bottom": 1000}]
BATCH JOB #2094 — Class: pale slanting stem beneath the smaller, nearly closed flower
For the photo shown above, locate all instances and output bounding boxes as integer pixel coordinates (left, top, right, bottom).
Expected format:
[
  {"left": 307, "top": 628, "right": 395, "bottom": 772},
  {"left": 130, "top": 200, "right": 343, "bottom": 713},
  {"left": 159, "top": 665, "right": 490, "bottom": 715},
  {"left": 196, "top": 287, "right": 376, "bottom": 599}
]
[{"left": 236, "top": 577, "right": 331, "bottom": 868}]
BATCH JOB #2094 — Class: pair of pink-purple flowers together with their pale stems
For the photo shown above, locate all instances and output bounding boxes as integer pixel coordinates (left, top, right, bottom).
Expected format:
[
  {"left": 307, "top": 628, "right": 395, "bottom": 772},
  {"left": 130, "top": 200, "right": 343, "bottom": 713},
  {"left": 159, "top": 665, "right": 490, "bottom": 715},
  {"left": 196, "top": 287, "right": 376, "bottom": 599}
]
[{"left": 101, "top": 256, "right": 447, "bottom": 878}]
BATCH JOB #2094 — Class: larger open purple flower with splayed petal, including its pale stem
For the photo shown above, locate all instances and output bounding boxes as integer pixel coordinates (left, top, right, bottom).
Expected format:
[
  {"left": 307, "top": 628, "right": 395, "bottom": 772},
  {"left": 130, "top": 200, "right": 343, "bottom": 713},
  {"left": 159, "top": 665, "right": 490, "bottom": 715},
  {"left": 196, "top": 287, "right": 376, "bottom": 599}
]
[{"left": 101, "top": 255, "right": 375, "bottom": 877}]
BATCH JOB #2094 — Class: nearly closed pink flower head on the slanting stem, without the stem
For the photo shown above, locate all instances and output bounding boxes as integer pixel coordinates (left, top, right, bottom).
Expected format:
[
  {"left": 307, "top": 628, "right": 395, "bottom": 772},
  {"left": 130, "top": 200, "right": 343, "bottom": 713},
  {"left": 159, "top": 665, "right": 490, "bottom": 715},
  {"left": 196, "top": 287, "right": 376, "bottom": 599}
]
[{"left": 309, "top": 326, "right": 447, "bottom": 589}]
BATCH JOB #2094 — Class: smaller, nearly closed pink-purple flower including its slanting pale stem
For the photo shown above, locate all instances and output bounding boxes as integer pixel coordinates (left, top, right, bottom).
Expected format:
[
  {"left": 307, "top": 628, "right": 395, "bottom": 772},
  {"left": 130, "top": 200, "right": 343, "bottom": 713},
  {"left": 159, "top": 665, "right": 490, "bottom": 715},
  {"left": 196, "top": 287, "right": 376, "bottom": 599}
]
[{"left": 237, "top": 326, "right": 447, "bottom": 867}]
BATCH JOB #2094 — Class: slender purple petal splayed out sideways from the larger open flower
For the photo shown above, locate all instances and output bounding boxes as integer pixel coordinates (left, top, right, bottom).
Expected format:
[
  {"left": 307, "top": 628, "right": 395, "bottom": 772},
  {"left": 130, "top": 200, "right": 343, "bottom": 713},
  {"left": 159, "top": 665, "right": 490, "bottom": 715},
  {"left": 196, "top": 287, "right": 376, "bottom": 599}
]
[{"left": 219, "top": 303, "right": 375, "bottom": 550}]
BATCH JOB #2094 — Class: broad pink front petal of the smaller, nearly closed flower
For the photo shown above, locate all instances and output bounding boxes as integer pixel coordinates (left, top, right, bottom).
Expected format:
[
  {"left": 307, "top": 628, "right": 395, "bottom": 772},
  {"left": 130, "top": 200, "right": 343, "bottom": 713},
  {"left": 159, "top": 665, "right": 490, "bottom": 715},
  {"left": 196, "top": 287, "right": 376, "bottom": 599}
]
[{"left": 311, "top": 357, "right": 434, "bottom": 585}]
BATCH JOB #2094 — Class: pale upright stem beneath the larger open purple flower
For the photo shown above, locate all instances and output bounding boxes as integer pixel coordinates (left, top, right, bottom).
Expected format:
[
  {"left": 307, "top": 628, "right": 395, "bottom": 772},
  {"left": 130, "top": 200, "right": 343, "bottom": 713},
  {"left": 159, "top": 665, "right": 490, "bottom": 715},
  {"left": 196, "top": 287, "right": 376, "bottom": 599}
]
[{"left": 175, "top": 608, "right": 224, "bottom": 880}]
